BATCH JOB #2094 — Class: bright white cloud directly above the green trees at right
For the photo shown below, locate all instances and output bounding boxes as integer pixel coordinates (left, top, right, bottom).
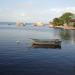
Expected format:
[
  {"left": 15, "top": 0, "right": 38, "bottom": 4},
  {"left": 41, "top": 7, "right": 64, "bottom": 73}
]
[{"left": 41, "top": 7, "right": 75, "bottom": 19}]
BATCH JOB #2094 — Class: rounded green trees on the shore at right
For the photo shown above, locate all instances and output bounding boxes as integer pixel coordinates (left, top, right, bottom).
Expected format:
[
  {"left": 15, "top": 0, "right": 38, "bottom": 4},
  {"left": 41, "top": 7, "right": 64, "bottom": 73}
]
[{"left": 52, "top": 12, "right": 74, "bottom": 26}]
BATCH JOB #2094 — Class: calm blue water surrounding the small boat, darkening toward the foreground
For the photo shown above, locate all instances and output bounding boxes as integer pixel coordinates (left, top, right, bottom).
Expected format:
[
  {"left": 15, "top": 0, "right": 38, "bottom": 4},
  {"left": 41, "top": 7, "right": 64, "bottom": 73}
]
[{"left": 0, "top": 24, "right": 75, "bottom": 75}]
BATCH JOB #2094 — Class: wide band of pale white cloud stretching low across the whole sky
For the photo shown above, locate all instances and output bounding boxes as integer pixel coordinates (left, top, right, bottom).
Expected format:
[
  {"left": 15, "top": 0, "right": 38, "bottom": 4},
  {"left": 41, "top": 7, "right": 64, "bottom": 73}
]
[{"left": 0, "top": 5, "right": 75, "bottom": 22}]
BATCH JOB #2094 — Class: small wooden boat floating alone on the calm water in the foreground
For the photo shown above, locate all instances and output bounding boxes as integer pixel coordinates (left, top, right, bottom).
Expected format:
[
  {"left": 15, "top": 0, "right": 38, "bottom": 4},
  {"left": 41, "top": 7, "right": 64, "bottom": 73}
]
[{"left": 32, "top": 39, "right": 61, "bottom": 48}]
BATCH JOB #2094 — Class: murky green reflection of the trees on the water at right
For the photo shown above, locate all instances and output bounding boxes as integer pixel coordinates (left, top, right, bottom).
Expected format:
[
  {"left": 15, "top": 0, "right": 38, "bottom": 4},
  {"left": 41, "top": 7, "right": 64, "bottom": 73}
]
[{"left": 60, "top": 29, "right": 75, "bottom": 43}]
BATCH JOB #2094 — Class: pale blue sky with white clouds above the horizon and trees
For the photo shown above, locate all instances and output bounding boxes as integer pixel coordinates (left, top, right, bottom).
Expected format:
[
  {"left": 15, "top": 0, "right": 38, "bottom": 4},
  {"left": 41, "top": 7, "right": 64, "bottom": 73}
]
[{"left": 0, "top": 0, "right": 75, "bottom": 22}]
